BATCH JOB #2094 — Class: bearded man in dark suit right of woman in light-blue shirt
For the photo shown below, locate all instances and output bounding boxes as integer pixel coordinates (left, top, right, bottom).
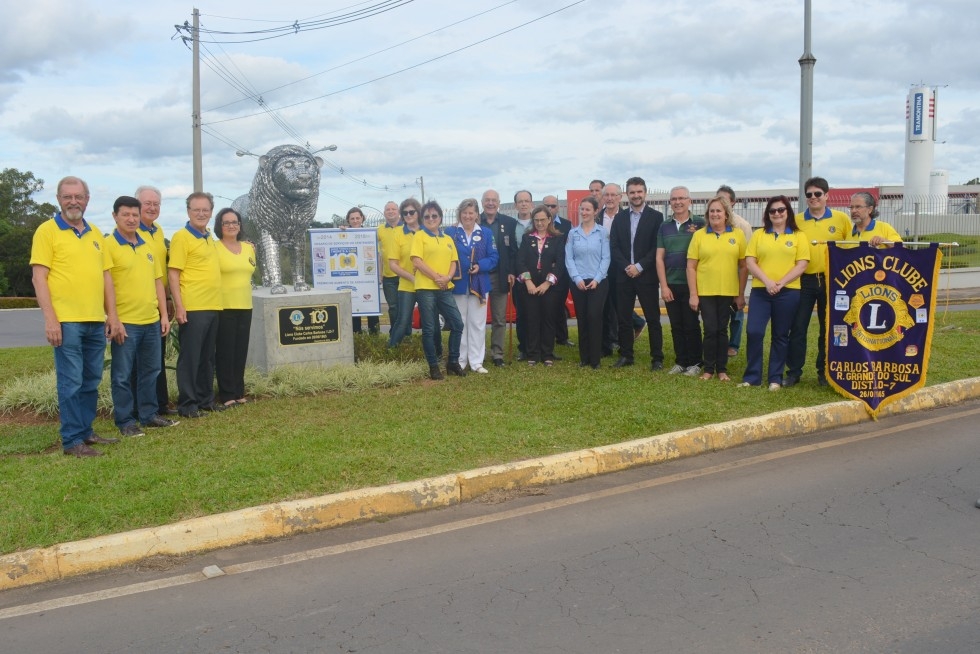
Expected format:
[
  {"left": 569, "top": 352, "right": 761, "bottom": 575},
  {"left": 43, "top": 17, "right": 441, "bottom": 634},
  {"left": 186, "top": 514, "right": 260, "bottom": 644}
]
[{"left": 609, "top": 177, "right": 664, "bottom": 370}]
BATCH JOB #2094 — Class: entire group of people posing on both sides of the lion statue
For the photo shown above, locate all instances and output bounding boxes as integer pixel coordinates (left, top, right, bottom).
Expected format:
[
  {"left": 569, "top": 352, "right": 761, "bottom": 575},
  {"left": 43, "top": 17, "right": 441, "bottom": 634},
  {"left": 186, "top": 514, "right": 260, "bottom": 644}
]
[{"left": 30, "top": 177, "right": 901, "bottom": 457}]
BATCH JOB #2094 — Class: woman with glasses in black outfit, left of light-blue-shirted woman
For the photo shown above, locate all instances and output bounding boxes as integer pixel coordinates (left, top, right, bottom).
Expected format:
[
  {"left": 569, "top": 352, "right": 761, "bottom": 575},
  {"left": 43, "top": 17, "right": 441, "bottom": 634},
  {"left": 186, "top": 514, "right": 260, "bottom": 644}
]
[{"left": 514, "top": 204, "right": 565, "bottom": 366}]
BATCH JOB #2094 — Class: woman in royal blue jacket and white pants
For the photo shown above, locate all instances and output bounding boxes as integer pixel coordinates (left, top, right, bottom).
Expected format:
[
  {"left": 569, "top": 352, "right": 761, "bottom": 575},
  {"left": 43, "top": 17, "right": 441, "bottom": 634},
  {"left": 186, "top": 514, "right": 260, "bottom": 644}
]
[{"left": 446, "top": 198, "right": 500, "bottom": 374}]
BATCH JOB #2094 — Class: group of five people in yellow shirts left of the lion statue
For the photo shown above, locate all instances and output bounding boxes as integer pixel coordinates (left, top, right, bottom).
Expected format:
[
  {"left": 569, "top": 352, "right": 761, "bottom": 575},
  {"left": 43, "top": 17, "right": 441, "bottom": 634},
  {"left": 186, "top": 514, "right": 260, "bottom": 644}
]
[{"left": 30, "top": 177, "right": 256, "bottom": 457}]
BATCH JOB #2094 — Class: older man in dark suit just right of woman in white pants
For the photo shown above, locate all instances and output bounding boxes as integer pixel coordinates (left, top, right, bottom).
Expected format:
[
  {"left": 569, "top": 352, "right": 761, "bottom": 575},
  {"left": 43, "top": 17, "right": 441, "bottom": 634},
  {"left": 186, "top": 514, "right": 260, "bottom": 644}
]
[{"left": 480, "top": 189, "right": 521, "bottom": 366}]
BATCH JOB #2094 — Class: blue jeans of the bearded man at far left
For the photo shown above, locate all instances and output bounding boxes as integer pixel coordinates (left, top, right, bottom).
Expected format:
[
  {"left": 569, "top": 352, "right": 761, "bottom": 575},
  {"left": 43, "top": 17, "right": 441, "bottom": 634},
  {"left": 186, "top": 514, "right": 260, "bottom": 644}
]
[{"left": 54, "top": 322, "right": 105, "bottom": 450}]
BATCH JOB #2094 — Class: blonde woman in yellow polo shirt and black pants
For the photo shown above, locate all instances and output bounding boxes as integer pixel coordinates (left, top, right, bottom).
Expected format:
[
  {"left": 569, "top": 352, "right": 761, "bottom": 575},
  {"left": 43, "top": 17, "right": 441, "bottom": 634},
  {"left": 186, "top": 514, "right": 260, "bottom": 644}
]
[{"left": 687, "top": 195, "right": 748, "bottom": 381}]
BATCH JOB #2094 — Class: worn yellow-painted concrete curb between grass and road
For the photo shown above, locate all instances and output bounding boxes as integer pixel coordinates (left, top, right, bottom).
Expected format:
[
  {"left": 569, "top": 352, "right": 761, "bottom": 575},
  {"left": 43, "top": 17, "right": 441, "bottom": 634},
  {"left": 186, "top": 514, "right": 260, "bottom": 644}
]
[{"left": 0, "top": 378, "right": 980, "bottom": 590}]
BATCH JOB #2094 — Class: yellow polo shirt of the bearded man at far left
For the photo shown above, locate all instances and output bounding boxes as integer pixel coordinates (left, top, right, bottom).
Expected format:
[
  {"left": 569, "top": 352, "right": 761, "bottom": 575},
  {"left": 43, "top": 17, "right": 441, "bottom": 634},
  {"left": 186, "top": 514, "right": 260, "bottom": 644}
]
[{"left": 31, "top": 213, "right": 108, "bottom": 322}]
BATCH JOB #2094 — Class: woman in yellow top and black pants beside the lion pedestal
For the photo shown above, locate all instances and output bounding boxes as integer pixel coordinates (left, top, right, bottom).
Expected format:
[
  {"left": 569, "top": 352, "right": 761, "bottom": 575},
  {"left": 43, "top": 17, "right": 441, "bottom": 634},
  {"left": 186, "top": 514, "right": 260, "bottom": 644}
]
[{"left": 214, "top": 209, "right": 255, "bottom": 407}]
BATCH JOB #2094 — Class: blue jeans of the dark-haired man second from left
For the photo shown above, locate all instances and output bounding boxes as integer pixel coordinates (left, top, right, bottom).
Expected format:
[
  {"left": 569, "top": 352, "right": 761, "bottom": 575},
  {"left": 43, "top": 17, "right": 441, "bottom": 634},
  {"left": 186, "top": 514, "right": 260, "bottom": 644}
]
[{"left": 110, "top": 322, "right": 161, "bottom": 429}]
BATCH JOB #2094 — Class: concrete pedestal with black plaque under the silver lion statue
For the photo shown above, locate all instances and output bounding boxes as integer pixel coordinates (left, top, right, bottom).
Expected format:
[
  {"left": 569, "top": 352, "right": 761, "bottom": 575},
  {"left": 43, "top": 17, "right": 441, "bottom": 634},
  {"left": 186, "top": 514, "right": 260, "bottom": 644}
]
[{"left": 248, "top": 288, "right": 354, "bottom": 372}]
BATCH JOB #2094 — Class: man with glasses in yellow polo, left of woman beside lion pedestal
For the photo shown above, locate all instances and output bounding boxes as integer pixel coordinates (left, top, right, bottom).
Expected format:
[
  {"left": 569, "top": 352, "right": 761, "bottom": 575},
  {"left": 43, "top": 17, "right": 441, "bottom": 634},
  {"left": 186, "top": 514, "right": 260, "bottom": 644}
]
[{"left": 167, "top": 191, "right": 224, "bottom": 418}]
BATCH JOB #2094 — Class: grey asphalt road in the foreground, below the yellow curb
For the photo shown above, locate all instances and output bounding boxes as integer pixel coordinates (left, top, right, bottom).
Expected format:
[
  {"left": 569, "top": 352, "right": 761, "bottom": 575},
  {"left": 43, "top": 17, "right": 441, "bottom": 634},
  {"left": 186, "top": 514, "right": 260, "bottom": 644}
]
[{"left": 0, "top": 402, "right": 980, "bottom": 654}]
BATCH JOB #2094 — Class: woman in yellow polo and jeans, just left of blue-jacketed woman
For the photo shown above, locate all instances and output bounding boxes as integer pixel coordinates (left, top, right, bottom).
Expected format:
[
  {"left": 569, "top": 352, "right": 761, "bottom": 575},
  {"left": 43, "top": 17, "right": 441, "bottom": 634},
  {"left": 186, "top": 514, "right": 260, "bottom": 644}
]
[{"left": 411, "top": 202, "right": 466, "bottom": 379}]
